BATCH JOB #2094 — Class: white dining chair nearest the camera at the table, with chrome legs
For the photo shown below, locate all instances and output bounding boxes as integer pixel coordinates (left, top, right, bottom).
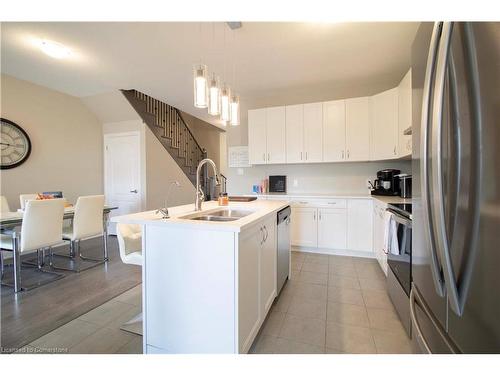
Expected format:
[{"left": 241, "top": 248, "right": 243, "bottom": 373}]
[{"left": 0, "top": 199, "right": 64, "bottom": 290}]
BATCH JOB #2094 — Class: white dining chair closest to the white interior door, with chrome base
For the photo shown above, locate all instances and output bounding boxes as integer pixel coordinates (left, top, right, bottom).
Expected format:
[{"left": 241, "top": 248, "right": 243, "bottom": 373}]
[{"left": 53, "top": 195, "right": 107, "bottom": 272}]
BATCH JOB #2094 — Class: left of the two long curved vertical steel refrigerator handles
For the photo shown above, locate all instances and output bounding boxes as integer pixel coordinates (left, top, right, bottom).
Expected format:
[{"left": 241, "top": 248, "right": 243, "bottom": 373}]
[{"left": 420, "top": 22, "right": 445, "bottom": 297}]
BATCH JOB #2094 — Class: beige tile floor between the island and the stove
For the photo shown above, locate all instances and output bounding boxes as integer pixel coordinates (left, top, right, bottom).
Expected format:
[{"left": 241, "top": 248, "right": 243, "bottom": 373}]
[{"left": 250, "top": 251, "right": 412, "bottom": 354}]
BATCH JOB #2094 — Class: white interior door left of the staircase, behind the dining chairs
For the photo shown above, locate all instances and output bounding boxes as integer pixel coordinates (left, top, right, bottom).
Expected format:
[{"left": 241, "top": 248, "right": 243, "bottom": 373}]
[{"left": 104, "top": 132, "right": 143, "bottom": 234}]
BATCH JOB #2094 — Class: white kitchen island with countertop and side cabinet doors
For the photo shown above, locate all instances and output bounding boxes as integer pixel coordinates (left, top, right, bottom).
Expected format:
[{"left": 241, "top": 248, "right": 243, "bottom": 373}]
[{"left": 111, "top": 200, "right": 288, "bottom": 353}]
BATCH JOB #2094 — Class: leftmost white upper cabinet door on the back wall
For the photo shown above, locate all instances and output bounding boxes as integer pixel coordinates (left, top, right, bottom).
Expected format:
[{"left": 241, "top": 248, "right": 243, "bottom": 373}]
[{"left": 248, "top": 108, "right": 267, "bottom": 164}]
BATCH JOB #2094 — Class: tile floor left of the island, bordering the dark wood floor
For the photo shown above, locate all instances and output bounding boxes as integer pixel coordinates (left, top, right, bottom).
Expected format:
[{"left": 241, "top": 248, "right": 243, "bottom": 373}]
[{"left": 18, "top": 285, "right": 142, "bottom": 354}]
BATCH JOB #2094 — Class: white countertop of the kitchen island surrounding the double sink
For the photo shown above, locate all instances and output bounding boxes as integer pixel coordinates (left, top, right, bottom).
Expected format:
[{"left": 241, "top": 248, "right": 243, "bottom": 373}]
[{"left": 110, "top": 200, "right": 289, "bottom": 232}]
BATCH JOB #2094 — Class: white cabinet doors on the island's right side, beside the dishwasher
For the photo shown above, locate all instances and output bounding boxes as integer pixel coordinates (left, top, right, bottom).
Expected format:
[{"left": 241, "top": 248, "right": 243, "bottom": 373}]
[{"left": 238, "top": 216, "right": 277, "bottom": 353}]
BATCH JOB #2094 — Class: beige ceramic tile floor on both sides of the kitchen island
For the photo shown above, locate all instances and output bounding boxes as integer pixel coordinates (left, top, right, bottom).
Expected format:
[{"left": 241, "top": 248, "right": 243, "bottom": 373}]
[{"left": 19, "top": 251, "right": 411, "bottom": 354}]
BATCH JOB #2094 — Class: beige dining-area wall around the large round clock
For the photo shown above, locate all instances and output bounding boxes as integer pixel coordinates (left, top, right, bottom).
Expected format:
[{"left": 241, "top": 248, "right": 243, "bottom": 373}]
[{"left": 1, "top": 74, "right": 103, "bottom": 210}]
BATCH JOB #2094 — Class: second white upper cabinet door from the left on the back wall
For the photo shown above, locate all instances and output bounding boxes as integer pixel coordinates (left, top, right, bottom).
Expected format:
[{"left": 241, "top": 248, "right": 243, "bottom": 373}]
[{"left": 261, "top": 107, "right": 286, "bottom": 164}]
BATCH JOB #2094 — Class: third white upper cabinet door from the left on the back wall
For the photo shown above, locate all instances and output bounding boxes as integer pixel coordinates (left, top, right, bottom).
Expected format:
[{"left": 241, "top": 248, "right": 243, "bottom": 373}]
[{"left": 285, "top": 104, "right": 305, "bottom": 163}]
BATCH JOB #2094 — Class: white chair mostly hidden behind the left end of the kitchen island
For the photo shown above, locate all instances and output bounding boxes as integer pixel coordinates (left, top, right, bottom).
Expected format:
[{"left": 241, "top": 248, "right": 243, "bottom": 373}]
[{"left": 116, "top": 224, "right": 143, "bottom": 335}]
